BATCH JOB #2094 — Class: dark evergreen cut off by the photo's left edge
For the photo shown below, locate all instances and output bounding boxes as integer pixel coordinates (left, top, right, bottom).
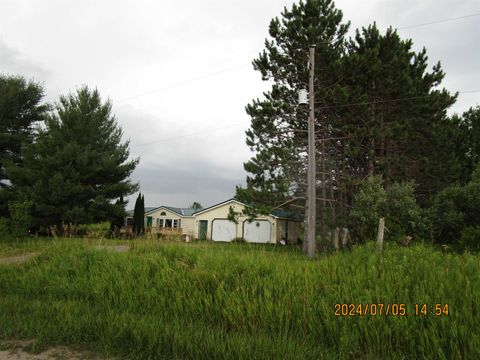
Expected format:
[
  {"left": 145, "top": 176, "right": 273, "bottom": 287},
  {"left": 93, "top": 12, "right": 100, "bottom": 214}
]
[{"left": 0, "top": 74, "right": 48, "bottom": 217}]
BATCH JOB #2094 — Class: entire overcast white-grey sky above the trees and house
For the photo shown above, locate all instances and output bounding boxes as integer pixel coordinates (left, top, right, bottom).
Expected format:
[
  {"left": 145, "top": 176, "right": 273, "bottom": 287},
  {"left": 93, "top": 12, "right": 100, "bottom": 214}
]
[{"left": 0, "top": 0, "right": 480, "bottom": 207}]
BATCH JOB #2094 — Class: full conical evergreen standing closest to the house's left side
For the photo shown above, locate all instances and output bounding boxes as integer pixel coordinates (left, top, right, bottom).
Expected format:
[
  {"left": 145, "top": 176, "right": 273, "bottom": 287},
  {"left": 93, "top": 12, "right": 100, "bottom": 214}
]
[{"left": 7, "top": 87, "right": 138, "bottom": 227}]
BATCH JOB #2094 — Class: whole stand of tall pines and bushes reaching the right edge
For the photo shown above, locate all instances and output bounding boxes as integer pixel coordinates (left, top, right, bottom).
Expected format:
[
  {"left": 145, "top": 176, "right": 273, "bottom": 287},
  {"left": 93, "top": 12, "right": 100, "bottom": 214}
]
[{"left": 236, "top": 0, "right": 480, "bottom": 250}]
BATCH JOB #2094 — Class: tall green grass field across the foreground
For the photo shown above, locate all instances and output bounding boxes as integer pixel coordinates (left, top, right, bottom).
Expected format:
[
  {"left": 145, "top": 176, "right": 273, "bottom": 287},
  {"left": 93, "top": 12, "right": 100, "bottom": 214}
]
[{"left": 0, "top": 239, "right": 480, "bottom": 359}]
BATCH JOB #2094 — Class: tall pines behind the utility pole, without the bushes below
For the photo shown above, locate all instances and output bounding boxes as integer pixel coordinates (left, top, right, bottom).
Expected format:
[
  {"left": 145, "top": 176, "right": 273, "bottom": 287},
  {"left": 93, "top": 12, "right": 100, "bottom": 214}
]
[{"left": 236, "top": 0, "right": 459, "bottom": 242}]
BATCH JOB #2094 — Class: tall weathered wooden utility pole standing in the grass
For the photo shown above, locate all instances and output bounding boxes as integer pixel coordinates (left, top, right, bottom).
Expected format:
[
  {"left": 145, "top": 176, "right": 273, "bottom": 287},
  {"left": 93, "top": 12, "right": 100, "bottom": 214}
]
[{"left": 307, "top": 45, "right": 317, "bottom": 258}]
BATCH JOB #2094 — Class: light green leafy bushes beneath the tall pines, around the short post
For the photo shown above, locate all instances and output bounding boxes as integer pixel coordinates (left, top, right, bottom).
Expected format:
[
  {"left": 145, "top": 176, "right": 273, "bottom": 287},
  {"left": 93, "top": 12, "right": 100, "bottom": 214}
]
[{"left": 350, "top": 176, "right": 430, "bottom": 242}]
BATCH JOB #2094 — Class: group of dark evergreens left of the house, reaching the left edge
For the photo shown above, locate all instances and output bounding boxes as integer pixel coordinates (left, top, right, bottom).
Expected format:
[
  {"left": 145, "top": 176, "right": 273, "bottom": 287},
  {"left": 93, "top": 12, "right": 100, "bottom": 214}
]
[{"left": 0, "top": 74, "right": 139, "bottom": 236}]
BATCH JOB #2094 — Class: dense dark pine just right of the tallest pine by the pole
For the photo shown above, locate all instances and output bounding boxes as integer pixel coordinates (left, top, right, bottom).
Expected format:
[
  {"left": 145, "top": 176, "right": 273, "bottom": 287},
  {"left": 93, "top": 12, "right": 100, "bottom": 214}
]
[{"left": 340, "top": 24, "right": 456, "bottom": 201}]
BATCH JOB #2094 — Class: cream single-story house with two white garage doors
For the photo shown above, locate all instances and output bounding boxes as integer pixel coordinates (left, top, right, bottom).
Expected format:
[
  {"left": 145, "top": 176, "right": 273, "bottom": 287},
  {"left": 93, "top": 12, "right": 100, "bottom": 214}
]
[{"left": 127, "top": 199, "right": 303, "bottom": 244}]
